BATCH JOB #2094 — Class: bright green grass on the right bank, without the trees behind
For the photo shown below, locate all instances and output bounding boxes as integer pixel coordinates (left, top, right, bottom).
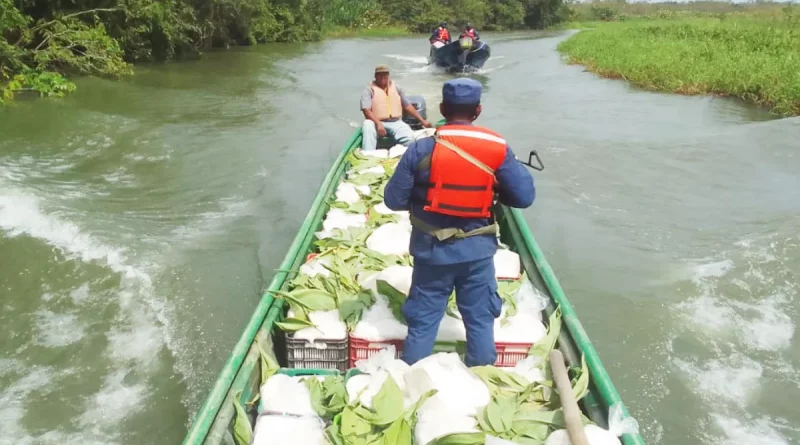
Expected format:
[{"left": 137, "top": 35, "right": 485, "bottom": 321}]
[{"left": 557, "top": 16, "right": 800, "bottom": 117}]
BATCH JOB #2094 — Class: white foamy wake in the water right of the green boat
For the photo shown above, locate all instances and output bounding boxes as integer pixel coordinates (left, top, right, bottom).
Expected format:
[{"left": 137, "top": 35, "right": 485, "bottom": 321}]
[{"left": 672, "top": 236, "right": 800, "bottom": 445}]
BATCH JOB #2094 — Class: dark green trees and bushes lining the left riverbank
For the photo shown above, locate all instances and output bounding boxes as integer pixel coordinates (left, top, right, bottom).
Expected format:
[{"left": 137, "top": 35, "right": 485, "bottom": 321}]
[{"left": 0, "top": 0, "right": 568, "bottom": 103}]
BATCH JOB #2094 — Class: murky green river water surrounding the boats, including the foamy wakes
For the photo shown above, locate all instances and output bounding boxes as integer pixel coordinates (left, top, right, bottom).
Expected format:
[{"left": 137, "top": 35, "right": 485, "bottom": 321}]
[{"left": 0, "top": 32, "right": 800, "bottom": 445}]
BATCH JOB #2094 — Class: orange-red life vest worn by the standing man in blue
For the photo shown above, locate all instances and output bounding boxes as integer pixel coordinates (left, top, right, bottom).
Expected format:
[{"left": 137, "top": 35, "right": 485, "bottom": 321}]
[{"left": 423, "top": 125, "right": 507, "bottom": 218}]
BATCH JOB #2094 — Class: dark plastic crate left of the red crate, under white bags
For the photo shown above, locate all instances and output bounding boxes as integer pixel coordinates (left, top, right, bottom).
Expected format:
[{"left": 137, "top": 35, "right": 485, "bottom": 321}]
[{"left": 286, "top": 334, "right": 349, "bottom": 373}]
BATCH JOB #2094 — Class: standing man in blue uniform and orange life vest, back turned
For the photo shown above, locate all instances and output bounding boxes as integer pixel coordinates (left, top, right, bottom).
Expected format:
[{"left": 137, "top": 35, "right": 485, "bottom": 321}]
[{"left": 384, "top": 78, "right": 536, "bottom": 366}]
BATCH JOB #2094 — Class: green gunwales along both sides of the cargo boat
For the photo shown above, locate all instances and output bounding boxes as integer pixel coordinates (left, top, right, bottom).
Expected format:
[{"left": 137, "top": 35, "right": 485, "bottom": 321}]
[{"left": 183, "top": 122, "right": 645, "bottom": 445}]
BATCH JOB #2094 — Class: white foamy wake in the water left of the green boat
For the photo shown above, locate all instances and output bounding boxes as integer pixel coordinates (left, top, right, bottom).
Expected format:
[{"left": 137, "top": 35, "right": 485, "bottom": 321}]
[{"left": 0, "top": 180, "right": 171, "bottom": 444}]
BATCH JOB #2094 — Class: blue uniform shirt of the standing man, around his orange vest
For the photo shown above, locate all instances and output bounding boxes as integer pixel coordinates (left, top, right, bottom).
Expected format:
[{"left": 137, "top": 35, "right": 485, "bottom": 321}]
[{"left": 383, "top": 122, "right": 536, "bottom": 265}]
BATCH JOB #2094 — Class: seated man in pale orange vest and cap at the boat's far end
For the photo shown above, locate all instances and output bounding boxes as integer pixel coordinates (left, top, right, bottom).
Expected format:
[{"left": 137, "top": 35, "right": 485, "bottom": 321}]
[{"left": 361, "top": 65, "right": 432, "bottom": 151}]
